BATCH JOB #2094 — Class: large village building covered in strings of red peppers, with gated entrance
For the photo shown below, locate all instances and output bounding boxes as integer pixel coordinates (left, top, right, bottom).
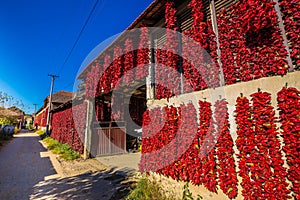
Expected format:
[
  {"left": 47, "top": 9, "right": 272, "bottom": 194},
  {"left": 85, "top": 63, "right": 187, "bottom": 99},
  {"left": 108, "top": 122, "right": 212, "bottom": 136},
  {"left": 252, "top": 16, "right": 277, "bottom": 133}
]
[{"left": 47, "top": 0, "right": 300, "bottom": 199}]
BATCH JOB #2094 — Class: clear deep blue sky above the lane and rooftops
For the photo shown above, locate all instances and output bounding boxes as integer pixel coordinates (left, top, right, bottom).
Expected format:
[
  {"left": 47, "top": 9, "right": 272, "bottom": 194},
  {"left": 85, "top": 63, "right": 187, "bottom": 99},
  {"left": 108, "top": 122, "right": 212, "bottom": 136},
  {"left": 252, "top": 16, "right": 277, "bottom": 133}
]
[{"left": 0, "top": 0, "right": 152, "bottom": 113}]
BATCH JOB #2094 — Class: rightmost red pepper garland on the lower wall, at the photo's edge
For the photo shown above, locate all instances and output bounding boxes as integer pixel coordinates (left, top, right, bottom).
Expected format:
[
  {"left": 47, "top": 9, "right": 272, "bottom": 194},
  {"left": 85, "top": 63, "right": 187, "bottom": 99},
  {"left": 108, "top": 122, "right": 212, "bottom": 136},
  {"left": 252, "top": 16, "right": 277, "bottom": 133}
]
[{"left": 277, "top": 87, "right": 300, "bottom": 199}]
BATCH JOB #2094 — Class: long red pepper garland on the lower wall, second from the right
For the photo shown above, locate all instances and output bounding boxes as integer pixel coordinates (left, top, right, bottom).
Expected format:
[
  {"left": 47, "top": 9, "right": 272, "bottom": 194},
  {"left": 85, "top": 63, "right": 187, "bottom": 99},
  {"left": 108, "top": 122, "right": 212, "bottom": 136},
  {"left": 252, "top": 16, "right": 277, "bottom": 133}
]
[{"left": 251, "top": 92, "right": 290, "bottom": 199}]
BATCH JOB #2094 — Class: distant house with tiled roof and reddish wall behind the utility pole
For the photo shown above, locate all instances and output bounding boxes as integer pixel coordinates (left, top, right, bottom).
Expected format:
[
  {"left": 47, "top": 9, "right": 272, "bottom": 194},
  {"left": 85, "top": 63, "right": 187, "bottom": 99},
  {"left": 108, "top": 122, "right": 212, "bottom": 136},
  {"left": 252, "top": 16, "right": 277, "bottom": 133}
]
[{"left": 34, "top": 91, "right": 73, "bottom": 128}]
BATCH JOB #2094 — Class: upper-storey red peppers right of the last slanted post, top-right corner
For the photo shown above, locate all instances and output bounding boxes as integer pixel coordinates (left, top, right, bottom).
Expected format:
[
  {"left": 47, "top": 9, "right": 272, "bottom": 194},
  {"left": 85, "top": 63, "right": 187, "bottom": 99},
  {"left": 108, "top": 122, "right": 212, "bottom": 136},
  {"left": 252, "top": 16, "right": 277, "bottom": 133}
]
[{"left": 280, "top": 0, "right": 300, "bottom": 70}]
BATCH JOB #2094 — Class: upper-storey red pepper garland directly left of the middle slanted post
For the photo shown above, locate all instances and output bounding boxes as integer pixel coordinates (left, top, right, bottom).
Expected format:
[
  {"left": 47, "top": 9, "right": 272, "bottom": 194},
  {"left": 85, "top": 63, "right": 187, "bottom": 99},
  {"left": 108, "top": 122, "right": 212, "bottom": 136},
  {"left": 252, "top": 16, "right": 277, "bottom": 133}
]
[{"left": 182, "top": 0, "right": 219, "bottom": 92}]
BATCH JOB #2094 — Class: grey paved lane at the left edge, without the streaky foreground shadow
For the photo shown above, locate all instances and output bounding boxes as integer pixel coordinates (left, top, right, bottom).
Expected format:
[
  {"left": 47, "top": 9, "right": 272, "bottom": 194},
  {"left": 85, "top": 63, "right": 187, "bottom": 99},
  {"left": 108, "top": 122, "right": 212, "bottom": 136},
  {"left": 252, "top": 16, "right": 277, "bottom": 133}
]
[{"left": 0, "top": 132, "right": 56, "bottom": 200}]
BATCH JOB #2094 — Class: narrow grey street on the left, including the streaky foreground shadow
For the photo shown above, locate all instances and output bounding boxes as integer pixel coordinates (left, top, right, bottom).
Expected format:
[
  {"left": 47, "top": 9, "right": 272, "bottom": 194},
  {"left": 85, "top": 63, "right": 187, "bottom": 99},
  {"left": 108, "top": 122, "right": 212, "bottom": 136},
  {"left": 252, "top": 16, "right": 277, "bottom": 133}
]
[{"left": 0, "top": 132, "right": 134, "bottom": 200}]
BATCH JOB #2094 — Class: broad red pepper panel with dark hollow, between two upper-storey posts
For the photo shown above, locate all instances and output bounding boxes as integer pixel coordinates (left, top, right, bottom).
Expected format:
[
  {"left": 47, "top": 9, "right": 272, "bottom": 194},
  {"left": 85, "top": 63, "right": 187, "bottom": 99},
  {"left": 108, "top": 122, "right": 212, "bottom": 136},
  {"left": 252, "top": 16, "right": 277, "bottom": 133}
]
[{"left": 217, "top": 1, "right": 288, "bottom": 84}]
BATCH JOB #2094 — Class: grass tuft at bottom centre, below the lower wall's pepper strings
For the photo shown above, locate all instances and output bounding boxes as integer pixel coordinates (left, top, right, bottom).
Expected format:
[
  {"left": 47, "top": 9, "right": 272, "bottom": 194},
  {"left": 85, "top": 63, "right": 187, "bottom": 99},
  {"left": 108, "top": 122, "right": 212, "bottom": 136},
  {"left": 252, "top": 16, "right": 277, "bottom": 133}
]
[{"left": 125, "top": 177, "right": 172, "bottom": 200}]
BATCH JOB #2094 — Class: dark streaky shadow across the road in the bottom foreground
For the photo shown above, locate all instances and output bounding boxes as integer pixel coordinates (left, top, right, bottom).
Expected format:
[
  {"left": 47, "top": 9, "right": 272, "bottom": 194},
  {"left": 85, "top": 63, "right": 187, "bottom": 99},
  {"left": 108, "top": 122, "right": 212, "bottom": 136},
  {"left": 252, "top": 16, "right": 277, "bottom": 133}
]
[{"left": 30, "top": 169, "right": 131, "bottom": 200}]
